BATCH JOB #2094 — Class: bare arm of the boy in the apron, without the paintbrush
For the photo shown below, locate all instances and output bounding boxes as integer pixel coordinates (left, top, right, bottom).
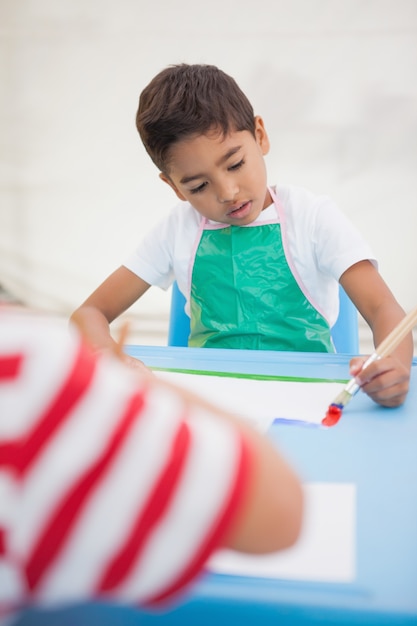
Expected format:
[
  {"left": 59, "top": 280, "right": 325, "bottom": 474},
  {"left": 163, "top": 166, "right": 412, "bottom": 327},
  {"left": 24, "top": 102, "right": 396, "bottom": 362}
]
[{"left": 70, "top": 266, "right": 150, "bottom": 368}]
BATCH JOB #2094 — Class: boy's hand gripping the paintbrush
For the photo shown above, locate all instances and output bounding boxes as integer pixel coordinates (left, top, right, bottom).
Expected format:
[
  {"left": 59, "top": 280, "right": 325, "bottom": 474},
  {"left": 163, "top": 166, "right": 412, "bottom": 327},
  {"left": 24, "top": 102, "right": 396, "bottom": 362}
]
[{"left": 350, "top": 356, "right": 410, "bottom": 408}]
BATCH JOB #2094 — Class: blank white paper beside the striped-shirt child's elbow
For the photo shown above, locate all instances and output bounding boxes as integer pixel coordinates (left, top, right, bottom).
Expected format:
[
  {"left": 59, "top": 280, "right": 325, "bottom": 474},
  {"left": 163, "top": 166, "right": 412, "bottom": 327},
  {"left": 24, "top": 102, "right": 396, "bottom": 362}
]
[{"left": 208, "top": 483, "right": 356, "bottom": 583}]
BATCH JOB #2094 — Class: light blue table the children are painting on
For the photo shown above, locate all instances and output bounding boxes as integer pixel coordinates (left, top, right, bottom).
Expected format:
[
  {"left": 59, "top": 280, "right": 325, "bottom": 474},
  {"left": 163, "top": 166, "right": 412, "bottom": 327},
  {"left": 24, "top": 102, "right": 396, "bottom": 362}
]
[{"left": 17, "top": 346, "right": 417, "bottom": 626}]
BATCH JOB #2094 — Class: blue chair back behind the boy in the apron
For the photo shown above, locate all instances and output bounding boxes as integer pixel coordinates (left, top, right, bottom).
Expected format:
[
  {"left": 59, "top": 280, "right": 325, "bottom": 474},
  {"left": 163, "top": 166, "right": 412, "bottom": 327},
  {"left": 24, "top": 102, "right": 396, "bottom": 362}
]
[{"left": 168, "top": 282, "right": 359, "bottom": 354}]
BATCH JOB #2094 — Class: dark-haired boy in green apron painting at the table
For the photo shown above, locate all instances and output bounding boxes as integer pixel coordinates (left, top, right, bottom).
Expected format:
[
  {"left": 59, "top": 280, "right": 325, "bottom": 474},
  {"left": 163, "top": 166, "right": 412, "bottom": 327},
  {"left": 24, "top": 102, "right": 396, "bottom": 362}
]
[{"left": 72, "top": 64, "right": 413, "bottom": 406}]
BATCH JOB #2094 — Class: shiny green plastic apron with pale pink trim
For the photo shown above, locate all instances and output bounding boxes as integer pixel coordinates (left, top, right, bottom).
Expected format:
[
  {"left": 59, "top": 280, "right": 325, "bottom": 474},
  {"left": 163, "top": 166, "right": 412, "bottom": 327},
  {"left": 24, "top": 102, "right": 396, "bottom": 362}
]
[{"left": 188, "top": 190, "right": 335, "bottom": 352}]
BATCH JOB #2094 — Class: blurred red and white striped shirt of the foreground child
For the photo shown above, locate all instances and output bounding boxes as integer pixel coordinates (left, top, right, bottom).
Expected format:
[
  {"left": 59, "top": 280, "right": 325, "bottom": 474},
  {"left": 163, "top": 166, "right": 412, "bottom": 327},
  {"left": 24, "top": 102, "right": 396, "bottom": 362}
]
[{"left": 0, "top": 313, "right": 251, "bottom": 609}]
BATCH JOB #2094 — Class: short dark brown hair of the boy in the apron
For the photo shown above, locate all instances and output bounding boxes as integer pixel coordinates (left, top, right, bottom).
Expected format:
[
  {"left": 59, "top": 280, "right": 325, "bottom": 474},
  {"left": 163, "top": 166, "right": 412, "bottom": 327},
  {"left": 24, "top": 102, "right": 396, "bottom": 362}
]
[{"left": 136, "top": 63, "right": 255, "bottom": 174}]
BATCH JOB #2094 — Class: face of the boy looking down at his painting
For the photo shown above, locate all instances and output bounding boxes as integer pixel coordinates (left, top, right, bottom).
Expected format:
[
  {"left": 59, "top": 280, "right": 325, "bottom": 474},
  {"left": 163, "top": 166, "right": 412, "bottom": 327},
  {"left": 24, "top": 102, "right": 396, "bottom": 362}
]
[{"left": 160, "top": 117, "right": 271, "bottom": 226}]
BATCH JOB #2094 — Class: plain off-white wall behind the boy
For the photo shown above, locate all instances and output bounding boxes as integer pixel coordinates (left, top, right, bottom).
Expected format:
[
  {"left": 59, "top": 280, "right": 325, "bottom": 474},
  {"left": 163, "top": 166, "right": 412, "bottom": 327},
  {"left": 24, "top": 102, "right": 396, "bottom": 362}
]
[{"left": 0, "top": 0, "right": 417, "bottom": 343}]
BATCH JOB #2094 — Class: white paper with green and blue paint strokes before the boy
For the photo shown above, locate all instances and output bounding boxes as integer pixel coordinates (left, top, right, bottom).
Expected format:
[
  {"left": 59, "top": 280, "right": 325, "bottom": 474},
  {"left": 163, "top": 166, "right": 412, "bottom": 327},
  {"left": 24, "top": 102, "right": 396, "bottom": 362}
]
[{"left": 155, "top": 371, "right": 344, "bottom": 432}]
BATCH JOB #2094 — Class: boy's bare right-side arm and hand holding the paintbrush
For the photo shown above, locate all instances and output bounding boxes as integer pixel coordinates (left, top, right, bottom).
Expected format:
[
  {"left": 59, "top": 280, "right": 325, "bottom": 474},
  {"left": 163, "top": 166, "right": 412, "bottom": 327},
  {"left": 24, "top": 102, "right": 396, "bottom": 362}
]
[{"left": 340, "top": 261, "right": 413, "bottom": 407}]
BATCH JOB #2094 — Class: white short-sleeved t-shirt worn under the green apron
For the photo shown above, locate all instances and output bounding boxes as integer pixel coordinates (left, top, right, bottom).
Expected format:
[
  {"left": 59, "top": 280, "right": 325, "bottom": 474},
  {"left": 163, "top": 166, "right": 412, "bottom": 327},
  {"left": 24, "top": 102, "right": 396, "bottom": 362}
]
[{"left": 124, "top": 187, "right": 376, "bottom": 326}]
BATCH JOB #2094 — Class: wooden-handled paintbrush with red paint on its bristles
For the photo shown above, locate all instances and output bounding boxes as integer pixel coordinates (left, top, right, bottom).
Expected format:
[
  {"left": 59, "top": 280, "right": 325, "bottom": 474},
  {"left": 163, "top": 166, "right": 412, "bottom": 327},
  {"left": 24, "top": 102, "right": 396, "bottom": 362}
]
[{"left": 322, "top": 307, "right": 417, "bottom": 426}]
